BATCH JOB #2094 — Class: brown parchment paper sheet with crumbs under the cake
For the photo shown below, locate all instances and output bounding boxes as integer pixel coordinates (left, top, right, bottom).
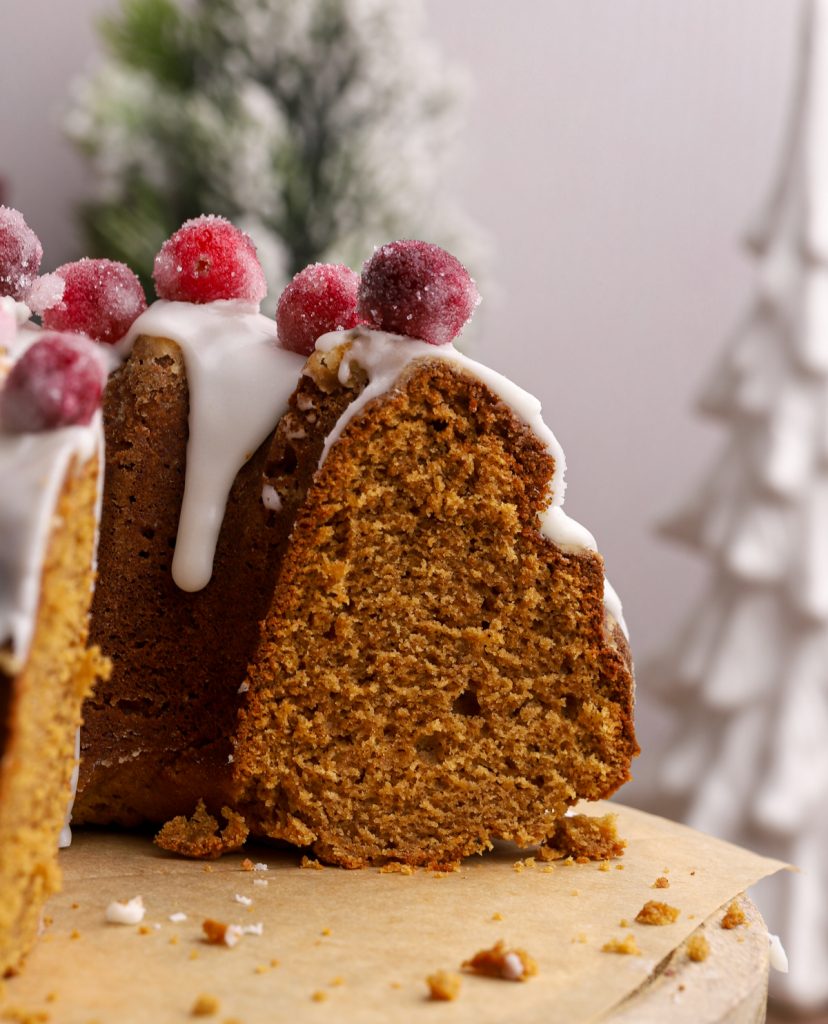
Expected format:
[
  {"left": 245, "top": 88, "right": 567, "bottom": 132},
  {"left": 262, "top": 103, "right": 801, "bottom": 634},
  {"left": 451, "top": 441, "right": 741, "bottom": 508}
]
[{"left": 0, "top": 804, "right": 785, "bottom": 1024}]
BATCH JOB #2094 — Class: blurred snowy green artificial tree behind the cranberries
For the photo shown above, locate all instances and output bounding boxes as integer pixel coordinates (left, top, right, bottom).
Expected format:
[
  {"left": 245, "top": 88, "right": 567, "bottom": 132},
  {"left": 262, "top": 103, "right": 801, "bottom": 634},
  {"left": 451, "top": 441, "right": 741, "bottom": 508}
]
[{"left": 67, "top": 0, "right": 485, "bottom": 296}]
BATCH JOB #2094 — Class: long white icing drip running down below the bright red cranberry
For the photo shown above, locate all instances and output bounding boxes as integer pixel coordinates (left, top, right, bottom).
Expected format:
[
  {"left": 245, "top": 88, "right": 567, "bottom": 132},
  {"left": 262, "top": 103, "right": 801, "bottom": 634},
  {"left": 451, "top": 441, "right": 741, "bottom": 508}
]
[{"left": 118, "top": 300, "right": 303, "bottom": 591}]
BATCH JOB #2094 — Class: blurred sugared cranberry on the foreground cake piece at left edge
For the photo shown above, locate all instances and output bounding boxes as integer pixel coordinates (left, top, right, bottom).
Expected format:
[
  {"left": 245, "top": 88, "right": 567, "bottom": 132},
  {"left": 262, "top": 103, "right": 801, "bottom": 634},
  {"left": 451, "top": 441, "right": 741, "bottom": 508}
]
[{"left": 0, "top": 334, "right": 106, "bottom": 434}]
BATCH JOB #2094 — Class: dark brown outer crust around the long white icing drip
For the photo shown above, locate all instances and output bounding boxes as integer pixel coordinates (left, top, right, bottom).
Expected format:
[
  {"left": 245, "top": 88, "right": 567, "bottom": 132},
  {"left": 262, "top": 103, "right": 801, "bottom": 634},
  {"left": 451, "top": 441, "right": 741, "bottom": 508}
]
[{"left": 75, "top": 338, "right": 294, "bottom": 825}]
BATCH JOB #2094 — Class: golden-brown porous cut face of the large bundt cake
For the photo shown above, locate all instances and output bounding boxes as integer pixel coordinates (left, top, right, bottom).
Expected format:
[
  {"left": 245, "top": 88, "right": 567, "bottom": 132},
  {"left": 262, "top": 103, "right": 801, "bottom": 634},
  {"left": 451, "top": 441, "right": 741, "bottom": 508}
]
[{"left": 234, "top": 351, "right": 638, "bottom": 867}]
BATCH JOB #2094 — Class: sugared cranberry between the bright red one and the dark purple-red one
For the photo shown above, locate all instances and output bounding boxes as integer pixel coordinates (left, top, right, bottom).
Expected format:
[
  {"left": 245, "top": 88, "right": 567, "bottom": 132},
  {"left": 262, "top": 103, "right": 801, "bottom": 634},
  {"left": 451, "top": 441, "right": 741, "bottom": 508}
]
[{"left": 276, "top": 263, "right": 359, "bottom": 355}]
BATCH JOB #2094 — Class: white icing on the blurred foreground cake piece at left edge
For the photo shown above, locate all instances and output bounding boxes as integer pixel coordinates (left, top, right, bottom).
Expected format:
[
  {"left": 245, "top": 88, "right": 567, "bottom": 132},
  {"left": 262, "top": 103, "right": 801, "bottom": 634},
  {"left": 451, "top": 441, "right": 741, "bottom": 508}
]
[{"left": 0, "top": 411, "right": 102, "bottom": 675}]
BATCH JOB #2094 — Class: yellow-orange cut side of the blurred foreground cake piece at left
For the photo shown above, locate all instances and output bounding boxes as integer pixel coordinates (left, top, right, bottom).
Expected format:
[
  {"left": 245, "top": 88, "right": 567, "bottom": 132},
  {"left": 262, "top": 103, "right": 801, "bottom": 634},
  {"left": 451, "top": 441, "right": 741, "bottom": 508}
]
[{"left": 0, "top": 459, "right": 103, "bottom": 976}]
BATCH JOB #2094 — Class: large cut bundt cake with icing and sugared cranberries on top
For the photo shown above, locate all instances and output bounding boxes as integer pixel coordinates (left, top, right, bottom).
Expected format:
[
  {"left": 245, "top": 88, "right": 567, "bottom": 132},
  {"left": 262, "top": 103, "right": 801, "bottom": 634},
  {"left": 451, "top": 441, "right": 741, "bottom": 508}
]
[{"left": 32, "top": 217, "right": 637, "bottom": 866}]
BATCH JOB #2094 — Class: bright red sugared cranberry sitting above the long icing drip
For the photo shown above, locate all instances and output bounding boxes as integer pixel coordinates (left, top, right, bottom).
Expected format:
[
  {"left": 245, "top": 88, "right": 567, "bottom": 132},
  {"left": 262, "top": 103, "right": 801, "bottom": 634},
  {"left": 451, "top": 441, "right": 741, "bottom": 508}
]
[{"left": 152, "top": 214, "right": 267, "bottom": 302}]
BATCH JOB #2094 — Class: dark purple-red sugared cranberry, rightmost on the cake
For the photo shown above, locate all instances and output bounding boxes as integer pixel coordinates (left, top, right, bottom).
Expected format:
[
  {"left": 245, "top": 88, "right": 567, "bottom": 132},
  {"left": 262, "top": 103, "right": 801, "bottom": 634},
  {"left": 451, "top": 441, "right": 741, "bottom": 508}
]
[{"left": 357, "top": 241, "right": 480, "bottom": 345}]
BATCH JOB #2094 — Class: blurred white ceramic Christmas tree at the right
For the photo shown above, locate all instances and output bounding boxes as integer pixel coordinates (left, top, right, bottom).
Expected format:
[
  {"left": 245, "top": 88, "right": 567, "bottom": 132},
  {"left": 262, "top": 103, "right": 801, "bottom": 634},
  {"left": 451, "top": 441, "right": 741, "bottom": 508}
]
[{"left": 654, "top": 0, "right": 828, "bottom": 1008}]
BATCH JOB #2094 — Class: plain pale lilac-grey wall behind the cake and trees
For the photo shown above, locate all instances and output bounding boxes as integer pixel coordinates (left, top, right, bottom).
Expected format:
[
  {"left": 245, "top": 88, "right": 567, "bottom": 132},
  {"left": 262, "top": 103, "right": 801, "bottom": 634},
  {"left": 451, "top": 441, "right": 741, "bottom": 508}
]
[{"left": 0, "top": 0, "right": 799, "bottom": 745}]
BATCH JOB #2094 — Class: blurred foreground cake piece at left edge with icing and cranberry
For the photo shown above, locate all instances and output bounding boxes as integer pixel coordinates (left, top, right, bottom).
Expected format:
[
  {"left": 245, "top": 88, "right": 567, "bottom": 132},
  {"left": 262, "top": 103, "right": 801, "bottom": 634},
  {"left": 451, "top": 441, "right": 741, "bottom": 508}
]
[{"left": 0, "top": 284, "right": 105, "bottom": 976}]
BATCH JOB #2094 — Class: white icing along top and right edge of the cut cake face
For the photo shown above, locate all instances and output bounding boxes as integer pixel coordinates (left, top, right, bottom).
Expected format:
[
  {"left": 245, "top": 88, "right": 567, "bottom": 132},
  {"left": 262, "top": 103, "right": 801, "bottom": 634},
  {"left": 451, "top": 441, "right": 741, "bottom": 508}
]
[{"left": 316, "top": 327, "right": 629, "bottom": 639}]
